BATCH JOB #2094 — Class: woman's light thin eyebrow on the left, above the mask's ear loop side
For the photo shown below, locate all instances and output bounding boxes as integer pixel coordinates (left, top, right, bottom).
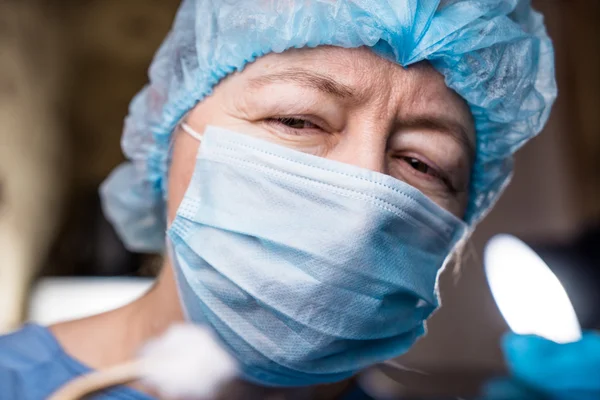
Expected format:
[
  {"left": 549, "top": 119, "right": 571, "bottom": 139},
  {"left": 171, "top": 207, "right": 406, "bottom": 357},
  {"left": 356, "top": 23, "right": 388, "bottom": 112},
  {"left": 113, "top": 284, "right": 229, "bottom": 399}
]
[{"left": 249, "top": 68, "right": 356, "bottom": 99}]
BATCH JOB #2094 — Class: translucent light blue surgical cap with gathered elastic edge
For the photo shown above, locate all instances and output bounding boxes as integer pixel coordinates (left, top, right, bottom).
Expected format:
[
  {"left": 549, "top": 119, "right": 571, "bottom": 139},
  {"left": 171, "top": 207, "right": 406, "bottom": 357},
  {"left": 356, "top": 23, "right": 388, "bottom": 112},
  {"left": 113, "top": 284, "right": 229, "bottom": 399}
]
[{"left": 101, "top": 0, "right": 556, "bottom": 251}]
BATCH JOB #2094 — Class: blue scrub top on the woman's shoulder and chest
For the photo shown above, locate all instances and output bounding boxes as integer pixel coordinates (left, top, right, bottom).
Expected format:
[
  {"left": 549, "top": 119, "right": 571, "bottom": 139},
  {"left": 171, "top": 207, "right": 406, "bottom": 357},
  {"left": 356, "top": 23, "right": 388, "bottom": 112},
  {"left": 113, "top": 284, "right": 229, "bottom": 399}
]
[{"left": 0, "top": 324, "right": 369, "bottom": 400}]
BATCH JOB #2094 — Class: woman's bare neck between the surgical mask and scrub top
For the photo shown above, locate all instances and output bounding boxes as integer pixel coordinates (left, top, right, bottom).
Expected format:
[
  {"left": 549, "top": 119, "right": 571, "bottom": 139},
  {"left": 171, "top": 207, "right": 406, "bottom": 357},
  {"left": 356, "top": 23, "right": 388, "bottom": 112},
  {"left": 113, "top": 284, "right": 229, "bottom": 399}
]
[{"left": 50, "top": 263, "right": 349, "bottom": 400}]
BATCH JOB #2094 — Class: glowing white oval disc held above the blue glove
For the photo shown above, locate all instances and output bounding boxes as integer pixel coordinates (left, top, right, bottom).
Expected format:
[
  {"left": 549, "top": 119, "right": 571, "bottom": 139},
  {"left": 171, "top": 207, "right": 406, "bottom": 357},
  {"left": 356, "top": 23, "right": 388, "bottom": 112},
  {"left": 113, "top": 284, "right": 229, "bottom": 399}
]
[{"left": 484, "top": 234, "right": 581, "bottom": 343}]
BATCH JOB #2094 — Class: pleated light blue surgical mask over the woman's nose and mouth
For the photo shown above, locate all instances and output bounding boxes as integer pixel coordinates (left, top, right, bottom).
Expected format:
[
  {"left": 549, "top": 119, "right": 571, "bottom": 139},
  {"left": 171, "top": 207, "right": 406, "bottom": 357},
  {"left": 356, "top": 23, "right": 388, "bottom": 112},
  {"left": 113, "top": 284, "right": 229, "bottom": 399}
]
[{"left": 168, "top": 127, "right": 467, "bottom": 386}]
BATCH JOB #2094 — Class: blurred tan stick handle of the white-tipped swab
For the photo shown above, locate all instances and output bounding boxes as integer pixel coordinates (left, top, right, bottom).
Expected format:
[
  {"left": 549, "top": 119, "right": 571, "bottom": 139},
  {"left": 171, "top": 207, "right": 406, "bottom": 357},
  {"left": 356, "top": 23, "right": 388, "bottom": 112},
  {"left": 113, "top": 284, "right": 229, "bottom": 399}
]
[{"left": 49, "top": 362, "right": 140, "bottom": 400}]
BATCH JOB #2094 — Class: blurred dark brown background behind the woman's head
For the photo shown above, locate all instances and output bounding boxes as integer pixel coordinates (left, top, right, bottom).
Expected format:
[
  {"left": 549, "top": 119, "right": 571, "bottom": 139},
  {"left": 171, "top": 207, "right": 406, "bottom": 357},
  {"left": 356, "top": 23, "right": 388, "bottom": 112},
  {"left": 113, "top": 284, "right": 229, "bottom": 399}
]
[{"left": 0, "top": 0, "right": 600, "bottom": 394}]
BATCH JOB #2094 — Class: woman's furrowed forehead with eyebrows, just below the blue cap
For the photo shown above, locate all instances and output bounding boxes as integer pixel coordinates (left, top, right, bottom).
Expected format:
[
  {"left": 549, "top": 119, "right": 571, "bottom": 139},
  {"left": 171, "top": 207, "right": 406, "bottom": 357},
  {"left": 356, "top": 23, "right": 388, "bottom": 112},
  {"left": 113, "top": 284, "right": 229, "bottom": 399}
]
[{"left": 236, "top": 46, "right": 475, "bottom": 147}]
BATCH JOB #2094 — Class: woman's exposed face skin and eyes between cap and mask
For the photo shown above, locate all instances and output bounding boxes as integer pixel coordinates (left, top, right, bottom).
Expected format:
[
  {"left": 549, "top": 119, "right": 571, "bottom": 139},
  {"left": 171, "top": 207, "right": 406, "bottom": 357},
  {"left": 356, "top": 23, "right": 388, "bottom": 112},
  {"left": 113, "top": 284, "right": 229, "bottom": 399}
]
[{"left": 168, "top": 47, "right": 475, "bottom": 222}]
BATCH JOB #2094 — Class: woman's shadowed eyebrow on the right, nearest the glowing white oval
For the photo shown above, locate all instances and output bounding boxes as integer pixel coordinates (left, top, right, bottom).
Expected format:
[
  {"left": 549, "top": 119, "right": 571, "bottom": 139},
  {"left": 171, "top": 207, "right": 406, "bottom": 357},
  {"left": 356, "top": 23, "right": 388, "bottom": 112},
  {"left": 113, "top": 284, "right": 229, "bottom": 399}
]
[{"left": 400, "top": 115, "right": 475, "bottom": 164}]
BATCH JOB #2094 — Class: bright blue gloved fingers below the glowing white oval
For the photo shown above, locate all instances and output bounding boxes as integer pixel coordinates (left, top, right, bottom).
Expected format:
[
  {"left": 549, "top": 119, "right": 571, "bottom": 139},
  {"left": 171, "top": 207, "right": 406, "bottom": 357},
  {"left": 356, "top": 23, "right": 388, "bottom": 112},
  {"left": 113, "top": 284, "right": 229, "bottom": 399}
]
[{"left": 485, "top": 332, "right": 600, "bottom": 400}]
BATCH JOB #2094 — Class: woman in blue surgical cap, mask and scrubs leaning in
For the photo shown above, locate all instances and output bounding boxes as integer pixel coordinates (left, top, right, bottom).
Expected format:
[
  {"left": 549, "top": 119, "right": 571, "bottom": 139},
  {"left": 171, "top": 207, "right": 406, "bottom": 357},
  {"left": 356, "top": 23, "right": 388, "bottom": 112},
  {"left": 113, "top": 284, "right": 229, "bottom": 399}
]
[{"left": 0, "top": 0, "right": 584, "bottom": 399}]
